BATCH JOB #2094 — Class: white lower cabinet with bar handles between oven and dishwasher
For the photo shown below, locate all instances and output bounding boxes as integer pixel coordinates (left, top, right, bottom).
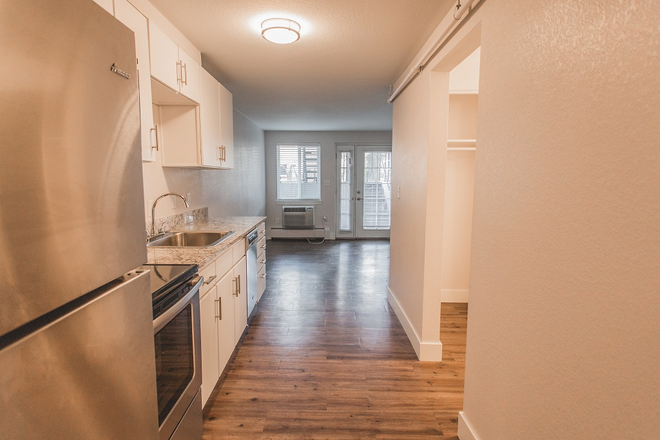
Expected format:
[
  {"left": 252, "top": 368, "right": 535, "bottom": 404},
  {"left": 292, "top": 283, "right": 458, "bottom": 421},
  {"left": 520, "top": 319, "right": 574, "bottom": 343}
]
[{"left": 200, "top": 240, "right": 247, "bottom": 405}]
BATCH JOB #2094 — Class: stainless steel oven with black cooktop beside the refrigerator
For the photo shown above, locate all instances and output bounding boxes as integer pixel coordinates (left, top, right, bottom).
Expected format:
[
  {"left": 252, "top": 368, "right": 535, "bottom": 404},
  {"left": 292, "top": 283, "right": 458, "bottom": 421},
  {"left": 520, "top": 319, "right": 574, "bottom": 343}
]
[{"left": 151, "top": 265, "right": 204, "bottom": 440}]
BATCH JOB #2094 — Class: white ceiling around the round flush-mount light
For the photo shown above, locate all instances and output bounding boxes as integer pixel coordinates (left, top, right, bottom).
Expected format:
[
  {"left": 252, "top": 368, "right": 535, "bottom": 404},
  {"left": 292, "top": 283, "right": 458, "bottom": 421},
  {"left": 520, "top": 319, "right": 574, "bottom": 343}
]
[{"left": 151, "top": 0, "right": 454, "bottom": 130}]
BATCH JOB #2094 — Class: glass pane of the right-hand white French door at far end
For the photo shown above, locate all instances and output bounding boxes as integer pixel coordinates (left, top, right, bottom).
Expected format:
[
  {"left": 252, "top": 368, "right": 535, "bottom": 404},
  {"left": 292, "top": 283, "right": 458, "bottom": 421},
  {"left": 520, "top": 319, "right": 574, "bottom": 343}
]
[{"left": 362, "top": 151, "right": 392, "bottom": 230}]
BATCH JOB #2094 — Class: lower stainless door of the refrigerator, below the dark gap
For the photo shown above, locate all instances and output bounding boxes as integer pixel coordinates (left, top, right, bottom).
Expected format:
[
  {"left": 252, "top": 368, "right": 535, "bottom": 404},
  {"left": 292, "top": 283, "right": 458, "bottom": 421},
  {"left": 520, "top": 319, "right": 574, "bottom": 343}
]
[{"left": 0, "top": 272, "right": 158, "bottom": 440}]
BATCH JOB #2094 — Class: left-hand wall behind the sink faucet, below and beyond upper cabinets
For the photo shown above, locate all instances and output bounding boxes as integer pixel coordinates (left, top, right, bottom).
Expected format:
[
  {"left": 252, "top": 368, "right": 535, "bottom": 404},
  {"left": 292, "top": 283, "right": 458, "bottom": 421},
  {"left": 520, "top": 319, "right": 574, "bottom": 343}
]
[{"left": 142, "top": 110, "right": 266, "bottom": 222}]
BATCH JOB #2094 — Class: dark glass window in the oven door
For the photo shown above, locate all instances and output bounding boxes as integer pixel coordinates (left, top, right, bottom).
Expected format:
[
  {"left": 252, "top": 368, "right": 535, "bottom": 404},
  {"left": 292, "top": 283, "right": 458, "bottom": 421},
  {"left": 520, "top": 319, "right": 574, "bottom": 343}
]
[{"left": 154, "top": 304, "right": 195, "bottom": 426}]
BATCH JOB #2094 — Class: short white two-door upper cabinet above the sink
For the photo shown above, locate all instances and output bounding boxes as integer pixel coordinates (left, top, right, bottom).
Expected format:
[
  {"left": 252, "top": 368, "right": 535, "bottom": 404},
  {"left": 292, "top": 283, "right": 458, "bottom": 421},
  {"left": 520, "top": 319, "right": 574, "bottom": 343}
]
[{"left": 149, "top": 21, "right": 201, "bottom": 102}]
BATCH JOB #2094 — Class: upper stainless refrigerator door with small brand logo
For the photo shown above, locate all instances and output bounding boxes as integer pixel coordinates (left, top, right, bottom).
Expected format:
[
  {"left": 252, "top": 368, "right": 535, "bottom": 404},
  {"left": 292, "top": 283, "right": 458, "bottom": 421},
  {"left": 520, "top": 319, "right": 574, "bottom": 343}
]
[{"left": 0, "top": 0, "right": 146, "bottom": 335}]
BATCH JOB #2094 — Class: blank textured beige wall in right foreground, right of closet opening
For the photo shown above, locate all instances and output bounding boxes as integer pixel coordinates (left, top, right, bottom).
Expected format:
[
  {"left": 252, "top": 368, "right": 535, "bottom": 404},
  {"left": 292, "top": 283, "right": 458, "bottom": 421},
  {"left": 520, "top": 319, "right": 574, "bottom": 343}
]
[{"left": 456, "top": 0, "right": 660, "bottom": 440}]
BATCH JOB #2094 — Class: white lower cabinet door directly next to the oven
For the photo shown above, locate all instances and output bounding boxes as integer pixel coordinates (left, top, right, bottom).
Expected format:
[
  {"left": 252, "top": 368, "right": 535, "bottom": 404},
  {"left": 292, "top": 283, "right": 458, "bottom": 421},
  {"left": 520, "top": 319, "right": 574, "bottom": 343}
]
[{"left": 199, "top": 286, "right": 220, "bottom": 406}]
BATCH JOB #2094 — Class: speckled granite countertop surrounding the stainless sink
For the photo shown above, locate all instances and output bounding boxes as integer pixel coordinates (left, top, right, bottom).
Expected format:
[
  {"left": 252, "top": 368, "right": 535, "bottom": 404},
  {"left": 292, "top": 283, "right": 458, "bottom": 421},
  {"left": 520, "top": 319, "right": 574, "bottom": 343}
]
[{"left": 147, "top": 217, "right": 266, "bottom": 269}]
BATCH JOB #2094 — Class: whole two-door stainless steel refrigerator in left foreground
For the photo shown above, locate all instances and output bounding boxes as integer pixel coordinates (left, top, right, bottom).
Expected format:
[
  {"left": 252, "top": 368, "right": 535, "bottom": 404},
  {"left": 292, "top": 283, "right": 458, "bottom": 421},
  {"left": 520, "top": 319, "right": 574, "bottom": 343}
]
[{"left": 0, "top": 0, "right": 158, "bottom": 439}]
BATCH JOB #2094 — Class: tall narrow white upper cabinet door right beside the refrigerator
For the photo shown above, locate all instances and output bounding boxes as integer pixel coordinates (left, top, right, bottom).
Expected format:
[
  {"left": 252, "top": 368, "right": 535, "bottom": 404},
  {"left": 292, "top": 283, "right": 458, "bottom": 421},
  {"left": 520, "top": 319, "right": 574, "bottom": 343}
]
[{"left": 115, "top": 0, "right": 156, "bottom": 162}]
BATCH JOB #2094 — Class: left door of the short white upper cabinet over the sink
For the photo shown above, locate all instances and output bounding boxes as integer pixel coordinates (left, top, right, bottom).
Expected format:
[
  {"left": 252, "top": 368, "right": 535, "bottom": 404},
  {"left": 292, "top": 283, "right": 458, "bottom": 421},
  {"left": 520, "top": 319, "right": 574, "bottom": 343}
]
[{"left": 149, "top": 21, "right": 180, "bottom": 91}]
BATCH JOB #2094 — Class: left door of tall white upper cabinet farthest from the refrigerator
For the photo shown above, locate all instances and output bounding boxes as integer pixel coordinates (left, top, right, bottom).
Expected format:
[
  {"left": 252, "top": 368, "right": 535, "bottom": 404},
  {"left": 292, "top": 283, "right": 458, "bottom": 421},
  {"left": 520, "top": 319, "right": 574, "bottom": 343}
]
[{"left": 199, "top": 69, "right": 220, "bottom": 167}]
